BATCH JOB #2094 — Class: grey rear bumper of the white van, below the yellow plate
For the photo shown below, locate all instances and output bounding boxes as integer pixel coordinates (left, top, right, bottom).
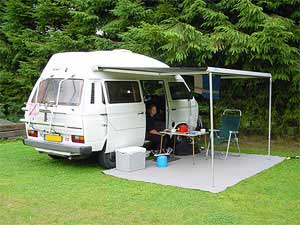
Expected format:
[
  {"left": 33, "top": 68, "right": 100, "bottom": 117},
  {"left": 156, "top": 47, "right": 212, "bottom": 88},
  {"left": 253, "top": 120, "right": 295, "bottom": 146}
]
[{"left": 23, "top": 138, "right": 92, "bottom": 155}]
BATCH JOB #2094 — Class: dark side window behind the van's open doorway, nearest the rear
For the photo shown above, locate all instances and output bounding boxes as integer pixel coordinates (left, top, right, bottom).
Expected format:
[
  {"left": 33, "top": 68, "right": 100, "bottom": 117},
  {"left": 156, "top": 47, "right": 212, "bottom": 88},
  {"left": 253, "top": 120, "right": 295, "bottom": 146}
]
[{"left": 105, "top": 81, "right": 141, "bottom": 104}]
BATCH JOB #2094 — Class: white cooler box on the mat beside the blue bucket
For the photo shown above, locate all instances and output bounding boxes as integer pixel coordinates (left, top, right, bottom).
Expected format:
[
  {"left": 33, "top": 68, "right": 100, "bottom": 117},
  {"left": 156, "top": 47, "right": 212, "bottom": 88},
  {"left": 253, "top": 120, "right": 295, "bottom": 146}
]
[{"left": 116, "top": 146, "right": 146, "bottom": 171}]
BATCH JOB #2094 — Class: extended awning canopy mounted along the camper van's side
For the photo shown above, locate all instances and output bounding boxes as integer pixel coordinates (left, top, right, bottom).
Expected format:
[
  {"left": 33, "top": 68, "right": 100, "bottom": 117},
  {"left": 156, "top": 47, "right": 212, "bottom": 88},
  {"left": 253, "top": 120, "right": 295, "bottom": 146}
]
[{"left": 97, "top": 67, "right": 271, "bottom": 79}]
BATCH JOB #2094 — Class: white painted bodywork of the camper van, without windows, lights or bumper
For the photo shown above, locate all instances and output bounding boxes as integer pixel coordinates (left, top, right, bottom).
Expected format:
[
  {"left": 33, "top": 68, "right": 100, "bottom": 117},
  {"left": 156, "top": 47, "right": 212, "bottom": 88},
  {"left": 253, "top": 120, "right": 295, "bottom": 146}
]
[{"left": 24, "top": 50, "right": 198, "bottom": 156}]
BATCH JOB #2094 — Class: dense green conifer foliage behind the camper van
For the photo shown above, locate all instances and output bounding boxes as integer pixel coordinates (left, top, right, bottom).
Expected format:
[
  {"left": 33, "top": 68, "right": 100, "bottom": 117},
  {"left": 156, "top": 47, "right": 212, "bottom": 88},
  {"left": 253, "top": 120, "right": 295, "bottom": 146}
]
[{"left": 0, "top": 0, "right": 300, "bottom": 136}]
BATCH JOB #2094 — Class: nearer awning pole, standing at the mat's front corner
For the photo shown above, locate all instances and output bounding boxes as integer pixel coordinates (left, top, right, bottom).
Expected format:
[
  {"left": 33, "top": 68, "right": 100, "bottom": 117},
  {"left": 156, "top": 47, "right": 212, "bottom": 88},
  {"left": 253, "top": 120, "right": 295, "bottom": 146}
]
[{"left": 209, "top": 73, "right": 215, "bottom": 187}]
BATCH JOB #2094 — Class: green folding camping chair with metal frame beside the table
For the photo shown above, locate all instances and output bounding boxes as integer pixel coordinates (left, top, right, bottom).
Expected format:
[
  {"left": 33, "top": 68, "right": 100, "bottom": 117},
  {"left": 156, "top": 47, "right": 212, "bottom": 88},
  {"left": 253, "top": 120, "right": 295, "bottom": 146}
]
[{"left": 206, "top": 109, "right": 242, "bottom": 160}]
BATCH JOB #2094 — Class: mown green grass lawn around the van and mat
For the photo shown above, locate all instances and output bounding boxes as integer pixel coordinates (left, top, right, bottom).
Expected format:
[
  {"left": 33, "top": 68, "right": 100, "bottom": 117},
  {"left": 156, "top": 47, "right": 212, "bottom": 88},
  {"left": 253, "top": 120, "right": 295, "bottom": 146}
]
[{"left": 0, "top": 139, "right": 300, "bottom": 225}]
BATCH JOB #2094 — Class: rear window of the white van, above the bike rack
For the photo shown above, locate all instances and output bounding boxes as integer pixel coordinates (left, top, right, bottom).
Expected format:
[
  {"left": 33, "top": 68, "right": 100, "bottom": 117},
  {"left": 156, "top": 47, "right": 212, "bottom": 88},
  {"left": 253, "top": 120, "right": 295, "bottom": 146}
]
[{"left": 32, "top": 78, "right": 83, "bottom": 106}]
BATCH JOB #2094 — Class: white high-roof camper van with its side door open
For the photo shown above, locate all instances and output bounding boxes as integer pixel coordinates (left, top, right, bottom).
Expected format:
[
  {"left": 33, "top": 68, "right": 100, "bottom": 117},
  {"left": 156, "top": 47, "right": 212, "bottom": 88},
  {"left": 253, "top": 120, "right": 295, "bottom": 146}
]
[{"left": 23, "top": 50, "right": 198, "bottom": 168}]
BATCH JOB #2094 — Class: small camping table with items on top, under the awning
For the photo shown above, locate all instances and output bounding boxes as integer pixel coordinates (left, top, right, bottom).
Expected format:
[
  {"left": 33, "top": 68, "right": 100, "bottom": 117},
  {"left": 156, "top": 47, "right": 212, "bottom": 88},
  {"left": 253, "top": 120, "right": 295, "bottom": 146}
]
[{"left": 159, "top": 131, "right": 209, "bottom": 165}]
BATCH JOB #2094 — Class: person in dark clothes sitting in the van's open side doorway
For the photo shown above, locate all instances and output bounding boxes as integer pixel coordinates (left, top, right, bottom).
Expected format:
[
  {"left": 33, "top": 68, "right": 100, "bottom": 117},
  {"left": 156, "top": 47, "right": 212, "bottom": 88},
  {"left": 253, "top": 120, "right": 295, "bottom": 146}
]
[{"left": 146, "top": 104, "right": 170, "bottom": 150}]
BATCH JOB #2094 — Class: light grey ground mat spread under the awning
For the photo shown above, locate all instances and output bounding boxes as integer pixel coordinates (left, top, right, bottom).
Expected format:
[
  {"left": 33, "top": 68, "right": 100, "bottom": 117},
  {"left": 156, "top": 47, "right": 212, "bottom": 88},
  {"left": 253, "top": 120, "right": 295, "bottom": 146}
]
[{"left": 103, "top": 152, "right": 284, "bottom": 193}]
